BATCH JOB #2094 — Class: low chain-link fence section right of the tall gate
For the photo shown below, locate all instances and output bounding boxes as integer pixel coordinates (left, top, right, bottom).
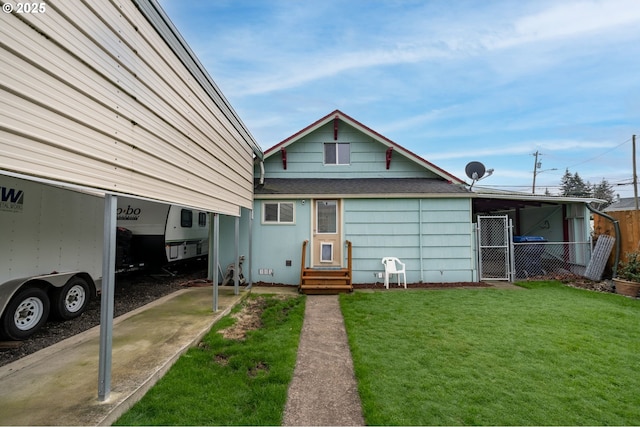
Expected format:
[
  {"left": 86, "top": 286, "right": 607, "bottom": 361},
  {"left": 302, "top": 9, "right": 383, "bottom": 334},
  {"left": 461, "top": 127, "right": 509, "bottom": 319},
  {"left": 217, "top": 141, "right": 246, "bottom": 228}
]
[{"left": 513, "top": 242, "right": 591, "bottom": 280}]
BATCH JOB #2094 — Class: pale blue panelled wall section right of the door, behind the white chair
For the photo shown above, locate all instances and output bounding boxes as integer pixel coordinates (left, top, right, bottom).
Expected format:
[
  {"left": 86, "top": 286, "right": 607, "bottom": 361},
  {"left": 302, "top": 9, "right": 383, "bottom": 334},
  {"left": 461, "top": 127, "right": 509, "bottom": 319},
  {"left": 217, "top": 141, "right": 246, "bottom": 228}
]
[{"left": 344, "top": 199, "right": 475, "bottom": 283}]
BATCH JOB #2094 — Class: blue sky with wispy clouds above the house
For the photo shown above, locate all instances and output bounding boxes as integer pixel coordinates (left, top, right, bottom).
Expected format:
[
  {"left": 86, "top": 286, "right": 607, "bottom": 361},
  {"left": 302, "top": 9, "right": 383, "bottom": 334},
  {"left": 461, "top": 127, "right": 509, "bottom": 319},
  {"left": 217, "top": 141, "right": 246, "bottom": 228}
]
[{"left": 160, "top": 0, "right": 640, "bottom": 197}]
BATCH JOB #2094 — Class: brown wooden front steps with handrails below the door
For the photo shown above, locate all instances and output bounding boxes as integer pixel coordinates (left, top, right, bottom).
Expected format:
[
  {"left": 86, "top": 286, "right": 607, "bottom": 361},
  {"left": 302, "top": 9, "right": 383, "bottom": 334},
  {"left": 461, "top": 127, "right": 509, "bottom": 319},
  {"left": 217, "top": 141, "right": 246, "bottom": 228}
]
[{"left": 298, "top": 240, "right": 353, "bottom": 295}]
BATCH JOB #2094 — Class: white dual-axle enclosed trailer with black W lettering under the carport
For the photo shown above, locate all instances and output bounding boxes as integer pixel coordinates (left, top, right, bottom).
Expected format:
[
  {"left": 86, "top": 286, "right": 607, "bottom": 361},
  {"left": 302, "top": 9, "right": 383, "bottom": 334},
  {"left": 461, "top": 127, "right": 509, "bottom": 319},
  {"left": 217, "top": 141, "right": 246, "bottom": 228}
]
[{"left": 0, "top": 175, "right": 104, "bottom": 340}]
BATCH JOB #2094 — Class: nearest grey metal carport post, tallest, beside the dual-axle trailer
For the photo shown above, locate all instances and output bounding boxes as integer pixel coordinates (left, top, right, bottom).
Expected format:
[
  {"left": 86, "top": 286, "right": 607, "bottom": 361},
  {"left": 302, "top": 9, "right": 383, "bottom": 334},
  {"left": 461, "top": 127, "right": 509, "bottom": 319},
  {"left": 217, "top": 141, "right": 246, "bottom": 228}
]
[{"left": 98, "top": 194, "right": 118, "bottom": 401}]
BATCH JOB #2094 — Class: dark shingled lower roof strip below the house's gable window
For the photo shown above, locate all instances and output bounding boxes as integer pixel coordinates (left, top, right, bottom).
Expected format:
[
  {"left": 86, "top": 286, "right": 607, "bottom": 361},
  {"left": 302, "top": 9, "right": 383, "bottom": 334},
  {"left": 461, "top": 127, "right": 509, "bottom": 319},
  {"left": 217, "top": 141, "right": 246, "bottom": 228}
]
[{"left": 254, "top": 178, "right": 473, "bottom": 197}]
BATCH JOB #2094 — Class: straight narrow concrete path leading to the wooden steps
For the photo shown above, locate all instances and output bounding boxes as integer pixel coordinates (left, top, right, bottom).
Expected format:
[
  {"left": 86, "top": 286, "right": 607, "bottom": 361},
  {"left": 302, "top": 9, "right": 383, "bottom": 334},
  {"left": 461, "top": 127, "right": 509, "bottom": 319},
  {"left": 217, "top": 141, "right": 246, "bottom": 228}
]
[{"left": 283, "top": 295, "right": 364, "bottom": 426}]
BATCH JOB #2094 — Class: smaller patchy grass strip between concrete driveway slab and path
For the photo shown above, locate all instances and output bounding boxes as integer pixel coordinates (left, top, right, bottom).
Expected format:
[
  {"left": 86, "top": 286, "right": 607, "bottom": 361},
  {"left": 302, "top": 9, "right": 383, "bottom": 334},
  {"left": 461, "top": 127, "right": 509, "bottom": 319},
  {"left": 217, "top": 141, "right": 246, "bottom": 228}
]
[{"left": 114, "top": 297, "right": 305, "bottom": 425}]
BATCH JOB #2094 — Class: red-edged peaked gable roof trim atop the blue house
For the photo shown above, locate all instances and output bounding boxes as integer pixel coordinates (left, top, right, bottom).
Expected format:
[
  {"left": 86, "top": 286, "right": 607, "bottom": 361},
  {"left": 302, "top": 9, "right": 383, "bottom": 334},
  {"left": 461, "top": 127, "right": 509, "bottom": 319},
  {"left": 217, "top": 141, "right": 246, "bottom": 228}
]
[{"left": 264, "top": 110, "right": 464, "bottom": 184}]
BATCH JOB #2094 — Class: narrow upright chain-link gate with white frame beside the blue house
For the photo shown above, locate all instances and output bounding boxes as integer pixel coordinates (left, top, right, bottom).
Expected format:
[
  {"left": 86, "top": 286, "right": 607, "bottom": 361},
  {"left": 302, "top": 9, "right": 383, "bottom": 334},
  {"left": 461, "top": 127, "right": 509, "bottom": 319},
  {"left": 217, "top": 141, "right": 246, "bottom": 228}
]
[{"left": 477, "top": 215, "right": 514, "bottom": 282}]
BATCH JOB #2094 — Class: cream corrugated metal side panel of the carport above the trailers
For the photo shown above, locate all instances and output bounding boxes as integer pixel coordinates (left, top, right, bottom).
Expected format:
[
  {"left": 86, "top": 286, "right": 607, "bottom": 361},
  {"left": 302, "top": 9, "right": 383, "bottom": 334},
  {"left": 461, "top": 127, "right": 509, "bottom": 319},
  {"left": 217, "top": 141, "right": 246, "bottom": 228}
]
[{"left": 0, "top": 0, "right": 262, "bottom": 215}]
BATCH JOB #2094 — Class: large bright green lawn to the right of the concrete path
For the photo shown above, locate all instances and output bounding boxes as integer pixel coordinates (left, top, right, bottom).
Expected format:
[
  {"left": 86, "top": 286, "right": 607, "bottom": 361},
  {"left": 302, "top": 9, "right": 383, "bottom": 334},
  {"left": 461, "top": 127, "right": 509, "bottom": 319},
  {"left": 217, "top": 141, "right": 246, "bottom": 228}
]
[{"left": 340, "top": 282, "right": 640, "bottom": 425}]
